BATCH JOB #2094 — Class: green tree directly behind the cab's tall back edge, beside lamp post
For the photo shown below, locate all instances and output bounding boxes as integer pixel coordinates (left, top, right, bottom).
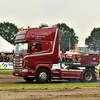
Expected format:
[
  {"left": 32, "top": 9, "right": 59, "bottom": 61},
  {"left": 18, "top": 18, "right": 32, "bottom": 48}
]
[{"left": 53, "top": 23, "right": 78, "bottom": 51}]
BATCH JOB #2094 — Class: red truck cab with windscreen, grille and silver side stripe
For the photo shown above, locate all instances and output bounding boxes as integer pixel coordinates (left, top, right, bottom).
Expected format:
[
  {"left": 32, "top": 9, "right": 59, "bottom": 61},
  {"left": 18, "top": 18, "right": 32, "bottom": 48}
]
[{"left": 13, "top": 27, "right": 59, "bottom": 80}]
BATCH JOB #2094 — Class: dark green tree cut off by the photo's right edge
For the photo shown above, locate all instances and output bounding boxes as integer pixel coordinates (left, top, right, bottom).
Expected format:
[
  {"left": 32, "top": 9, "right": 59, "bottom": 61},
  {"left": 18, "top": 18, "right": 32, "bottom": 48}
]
[{"left": 85, "top": 28, "right": 100, "bottom": 52}]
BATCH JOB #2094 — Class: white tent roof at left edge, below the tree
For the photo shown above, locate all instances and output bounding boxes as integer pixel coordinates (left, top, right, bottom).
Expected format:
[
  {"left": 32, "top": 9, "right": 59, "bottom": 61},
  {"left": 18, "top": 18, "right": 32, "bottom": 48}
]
[{"left": 0, "top": 36, "right": 15, "bottom": 53}]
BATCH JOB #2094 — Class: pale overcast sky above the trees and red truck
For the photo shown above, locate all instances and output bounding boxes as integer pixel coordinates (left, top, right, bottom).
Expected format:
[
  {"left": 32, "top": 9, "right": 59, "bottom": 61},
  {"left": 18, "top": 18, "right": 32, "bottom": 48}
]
[{"left": 0, "top": 0, "right": 100, "bottom": 47}]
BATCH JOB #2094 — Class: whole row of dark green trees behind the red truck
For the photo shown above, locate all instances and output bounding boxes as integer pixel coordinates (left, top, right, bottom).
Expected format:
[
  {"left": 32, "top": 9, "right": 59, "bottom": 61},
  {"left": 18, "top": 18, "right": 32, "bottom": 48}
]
[{"left": 0, "top": 22, "right": 100, "bottom": 51}]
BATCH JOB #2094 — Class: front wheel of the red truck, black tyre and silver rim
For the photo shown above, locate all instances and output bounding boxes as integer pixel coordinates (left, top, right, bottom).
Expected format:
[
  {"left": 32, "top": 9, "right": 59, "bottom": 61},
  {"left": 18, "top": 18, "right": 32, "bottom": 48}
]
[{"left": 36, "top": 69, "right": 50, "bottom": 83}]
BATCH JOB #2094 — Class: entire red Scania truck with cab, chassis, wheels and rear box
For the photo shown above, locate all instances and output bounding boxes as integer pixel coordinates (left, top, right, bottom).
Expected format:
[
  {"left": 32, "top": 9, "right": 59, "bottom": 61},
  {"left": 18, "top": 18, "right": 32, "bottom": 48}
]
[{"left": 13, "top": 27, "right": 99, "bottom": 83}]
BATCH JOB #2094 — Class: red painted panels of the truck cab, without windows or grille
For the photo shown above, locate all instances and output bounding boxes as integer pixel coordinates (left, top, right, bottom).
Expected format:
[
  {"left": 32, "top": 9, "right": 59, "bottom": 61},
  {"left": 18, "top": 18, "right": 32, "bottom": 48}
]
[{"left": 13, "top": 27, "right": 59, "bottom": 77}]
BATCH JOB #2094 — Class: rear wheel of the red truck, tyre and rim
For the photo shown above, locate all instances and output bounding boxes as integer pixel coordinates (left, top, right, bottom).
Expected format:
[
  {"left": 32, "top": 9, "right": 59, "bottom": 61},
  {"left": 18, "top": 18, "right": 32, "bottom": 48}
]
[{"left": 83, "top": 70, "right": 95, "bottom": 82}]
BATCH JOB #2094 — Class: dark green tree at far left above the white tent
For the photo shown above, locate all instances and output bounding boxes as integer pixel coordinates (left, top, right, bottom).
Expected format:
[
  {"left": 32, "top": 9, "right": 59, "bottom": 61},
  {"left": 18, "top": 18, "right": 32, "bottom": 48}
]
[{"left": 0, "top": 22, "right": 18, "bottom": 44}]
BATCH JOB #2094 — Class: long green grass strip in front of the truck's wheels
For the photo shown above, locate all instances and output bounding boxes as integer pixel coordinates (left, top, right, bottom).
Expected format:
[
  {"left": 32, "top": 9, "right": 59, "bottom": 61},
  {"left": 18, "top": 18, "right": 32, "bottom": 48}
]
[{"left": 0, "top": 83, "right": 100, "bottom": 89}]
